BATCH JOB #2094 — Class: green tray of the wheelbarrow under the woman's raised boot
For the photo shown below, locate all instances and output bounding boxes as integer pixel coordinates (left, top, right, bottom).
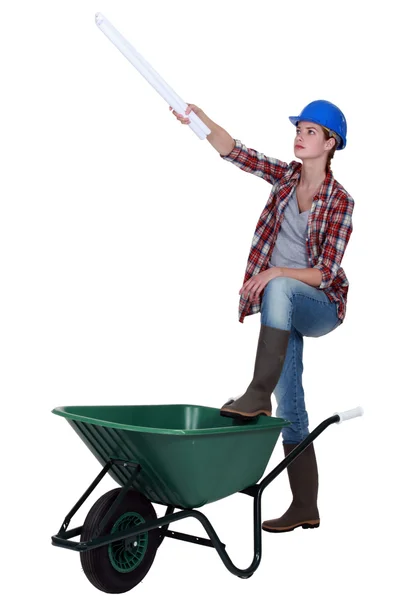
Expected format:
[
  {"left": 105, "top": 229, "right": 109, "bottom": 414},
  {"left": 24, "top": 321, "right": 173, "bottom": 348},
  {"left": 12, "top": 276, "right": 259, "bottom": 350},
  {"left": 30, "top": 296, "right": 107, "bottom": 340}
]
[{"left": 52, "top": 404, "right": 289, "bottom": 508}]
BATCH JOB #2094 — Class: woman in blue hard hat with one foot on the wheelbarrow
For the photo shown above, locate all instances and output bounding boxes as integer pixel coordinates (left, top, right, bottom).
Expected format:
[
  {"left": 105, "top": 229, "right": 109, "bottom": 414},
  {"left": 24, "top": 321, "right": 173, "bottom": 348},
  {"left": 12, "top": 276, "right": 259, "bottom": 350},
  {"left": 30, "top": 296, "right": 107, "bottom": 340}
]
[{"left": 170, "top": 100, "right": 354, "bottom": 532}]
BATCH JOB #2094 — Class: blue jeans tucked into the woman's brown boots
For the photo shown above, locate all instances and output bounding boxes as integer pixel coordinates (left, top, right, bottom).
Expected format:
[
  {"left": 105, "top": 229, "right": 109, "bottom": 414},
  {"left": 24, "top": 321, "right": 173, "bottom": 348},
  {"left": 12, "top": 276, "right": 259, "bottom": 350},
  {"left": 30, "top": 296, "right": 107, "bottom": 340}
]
[{"left": 261, "top": 277, "right": 341, "bottom": 444}]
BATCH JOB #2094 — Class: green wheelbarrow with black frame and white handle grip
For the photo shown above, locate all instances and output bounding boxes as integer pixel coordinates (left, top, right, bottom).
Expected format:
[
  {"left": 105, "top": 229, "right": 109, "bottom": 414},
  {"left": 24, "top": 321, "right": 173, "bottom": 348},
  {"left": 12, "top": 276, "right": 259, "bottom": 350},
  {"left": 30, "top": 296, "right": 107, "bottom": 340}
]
[{"left": 52, "top": 404, "right": 363, "bottom": 593}]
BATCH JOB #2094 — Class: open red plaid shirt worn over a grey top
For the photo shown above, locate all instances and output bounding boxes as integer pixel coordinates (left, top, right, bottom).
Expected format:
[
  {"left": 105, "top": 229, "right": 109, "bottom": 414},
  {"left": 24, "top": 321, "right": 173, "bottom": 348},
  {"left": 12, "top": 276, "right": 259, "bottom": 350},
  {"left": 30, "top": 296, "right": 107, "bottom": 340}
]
[{"left": 220, "top": 140, "right": 354, "bottom": 323}]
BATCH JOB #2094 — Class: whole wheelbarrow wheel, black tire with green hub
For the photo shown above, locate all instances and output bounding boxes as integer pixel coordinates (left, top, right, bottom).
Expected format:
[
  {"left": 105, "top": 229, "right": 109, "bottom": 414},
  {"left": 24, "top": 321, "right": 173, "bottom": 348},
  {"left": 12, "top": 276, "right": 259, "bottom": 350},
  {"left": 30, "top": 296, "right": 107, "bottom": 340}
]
[{"left": 80, "top": 488, "right": 159, "bottom": 594}]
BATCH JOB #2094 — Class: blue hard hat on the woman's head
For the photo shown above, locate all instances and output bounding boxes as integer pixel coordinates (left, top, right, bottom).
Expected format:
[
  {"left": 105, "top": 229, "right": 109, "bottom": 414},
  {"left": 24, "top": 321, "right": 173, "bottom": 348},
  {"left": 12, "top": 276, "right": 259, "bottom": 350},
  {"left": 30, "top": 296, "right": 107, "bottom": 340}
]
[{"left": 289, "top": 100, "right": 347, "bottom": 150}]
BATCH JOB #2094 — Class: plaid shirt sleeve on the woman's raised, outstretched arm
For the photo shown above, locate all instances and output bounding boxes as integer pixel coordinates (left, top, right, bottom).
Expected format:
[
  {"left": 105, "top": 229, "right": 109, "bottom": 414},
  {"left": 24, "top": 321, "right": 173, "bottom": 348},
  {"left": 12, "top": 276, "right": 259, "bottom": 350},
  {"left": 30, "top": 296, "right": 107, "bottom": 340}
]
[{"left": 220, "top": 140, "right": 289, "bottom": 185}]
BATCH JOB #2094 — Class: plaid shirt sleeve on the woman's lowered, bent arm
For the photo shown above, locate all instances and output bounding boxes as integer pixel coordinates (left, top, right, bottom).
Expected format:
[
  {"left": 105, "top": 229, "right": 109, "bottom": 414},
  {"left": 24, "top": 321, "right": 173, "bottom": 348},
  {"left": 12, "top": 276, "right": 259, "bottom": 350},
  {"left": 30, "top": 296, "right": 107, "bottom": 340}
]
[{"left": 314, "top": 194, "right": 354, "bottom": 289}]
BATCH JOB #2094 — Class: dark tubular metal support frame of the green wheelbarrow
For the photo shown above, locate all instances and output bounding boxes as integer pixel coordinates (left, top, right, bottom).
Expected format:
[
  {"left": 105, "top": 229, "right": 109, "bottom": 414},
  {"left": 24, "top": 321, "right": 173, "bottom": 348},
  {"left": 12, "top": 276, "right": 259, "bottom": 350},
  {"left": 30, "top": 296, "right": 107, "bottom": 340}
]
[{"left": 51, "top": 414, "right": 340, "bottom": 579}]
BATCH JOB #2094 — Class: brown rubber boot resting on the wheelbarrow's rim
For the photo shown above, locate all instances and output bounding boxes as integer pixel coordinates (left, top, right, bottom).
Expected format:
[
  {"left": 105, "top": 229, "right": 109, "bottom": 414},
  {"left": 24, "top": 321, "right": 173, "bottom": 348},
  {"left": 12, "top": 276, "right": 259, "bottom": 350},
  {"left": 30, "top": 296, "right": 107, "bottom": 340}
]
[{"left": 220, "top": 325, "right": 290, "bottom": 419}]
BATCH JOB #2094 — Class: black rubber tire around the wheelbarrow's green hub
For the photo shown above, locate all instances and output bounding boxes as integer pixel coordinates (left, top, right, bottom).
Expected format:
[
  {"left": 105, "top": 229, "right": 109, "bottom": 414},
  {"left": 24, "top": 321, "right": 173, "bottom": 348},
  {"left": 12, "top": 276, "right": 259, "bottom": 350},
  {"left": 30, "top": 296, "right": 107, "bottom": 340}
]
[{"left": 80, "top": 488, "right": 159, "bottom": 594}]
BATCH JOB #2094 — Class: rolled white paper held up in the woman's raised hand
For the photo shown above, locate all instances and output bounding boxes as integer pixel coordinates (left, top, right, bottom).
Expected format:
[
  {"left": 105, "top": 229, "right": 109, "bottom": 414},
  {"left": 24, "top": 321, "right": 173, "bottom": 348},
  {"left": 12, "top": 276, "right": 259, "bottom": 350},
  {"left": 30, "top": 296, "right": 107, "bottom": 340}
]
[{"left": 95, "top": 13, "right": 211, "bottom": 140}]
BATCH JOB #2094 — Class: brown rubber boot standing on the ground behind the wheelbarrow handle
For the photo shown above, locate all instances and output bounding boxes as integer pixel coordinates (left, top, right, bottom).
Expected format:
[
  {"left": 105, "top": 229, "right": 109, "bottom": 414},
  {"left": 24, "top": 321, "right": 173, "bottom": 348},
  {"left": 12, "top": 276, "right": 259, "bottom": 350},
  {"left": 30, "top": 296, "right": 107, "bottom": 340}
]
[{"left": 262, "top": 444, "right": 320, "bottom": 533}]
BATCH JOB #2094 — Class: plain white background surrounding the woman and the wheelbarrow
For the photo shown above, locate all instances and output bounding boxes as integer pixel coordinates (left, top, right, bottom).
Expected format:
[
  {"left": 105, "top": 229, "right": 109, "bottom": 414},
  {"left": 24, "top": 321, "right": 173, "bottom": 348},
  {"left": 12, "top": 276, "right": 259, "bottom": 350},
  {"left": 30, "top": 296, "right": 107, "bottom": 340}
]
[{"left": 0, "top": 0, "right": 399, "bottom": 600}]
